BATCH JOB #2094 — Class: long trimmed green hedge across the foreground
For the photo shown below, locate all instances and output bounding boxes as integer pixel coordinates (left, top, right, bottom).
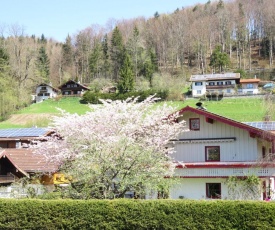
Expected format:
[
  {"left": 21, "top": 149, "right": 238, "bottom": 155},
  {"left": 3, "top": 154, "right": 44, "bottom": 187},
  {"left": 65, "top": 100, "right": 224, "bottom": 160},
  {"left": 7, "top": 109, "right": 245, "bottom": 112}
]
[{"left": 0, "top": 199, "right": 275, "bottom": 230}]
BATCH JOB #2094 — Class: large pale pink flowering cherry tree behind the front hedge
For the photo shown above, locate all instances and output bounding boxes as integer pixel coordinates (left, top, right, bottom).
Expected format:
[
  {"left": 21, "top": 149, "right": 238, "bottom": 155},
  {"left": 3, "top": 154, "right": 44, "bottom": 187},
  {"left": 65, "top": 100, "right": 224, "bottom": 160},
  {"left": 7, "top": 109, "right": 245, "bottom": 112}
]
[{"left": 37, "top": 97, "right": 185, "bottom": 198}]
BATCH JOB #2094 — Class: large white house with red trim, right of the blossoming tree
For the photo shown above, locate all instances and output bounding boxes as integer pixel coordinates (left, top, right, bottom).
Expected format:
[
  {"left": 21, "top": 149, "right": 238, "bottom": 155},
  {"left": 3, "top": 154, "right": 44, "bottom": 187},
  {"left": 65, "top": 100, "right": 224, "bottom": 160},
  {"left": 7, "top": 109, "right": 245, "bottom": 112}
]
[{"left": 170, "top": 106, "right": 275, "bottom": 200}]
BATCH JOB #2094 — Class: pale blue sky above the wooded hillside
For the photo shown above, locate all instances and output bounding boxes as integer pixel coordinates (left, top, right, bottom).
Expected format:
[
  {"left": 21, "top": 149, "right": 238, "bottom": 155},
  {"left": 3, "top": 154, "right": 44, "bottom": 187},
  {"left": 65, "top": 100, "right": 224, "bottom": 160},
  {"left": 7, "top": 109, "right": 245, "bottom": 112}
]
[{"left": 0, "top": 0, "right": 207, "bottom": 42}]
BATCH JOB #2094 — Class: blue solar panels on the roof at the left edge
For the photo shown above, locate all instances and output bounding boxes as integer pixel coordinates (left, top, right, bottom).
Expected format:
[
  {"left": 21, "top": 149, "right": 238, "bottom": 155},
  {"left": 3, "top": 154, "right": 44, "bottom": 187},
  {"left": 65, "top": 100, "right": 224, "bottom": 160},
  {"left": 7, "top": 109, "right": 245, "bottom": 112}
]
[{"left": 0, "top": 128, "right": 48, "bottom": 138}]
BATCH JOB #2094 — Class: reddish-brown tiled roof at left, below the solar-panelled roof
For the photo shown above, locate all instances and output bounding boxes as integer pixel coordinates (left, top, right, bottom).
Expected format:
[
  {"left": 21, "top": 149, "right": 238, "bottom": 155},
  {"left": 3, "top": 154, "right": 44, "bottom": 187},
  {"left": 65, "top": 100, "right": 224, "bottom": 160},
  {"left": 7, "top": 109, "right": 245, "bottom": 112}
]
[{"left": 0, "top": 148, "right": 58, "bottom": 175}]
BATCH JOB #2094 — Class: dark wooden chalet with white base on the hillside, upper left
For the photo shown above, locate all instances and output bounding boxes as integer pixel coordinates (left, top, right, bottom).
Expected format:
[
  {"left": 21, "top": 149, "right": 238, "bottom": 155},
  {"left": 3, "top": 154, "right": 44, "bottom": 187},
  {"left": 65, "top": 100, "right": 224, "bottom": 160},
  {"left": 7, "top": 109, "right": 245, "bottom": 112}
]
[{"left": 58, "top": 80, "right": 90, "bottom": 97}]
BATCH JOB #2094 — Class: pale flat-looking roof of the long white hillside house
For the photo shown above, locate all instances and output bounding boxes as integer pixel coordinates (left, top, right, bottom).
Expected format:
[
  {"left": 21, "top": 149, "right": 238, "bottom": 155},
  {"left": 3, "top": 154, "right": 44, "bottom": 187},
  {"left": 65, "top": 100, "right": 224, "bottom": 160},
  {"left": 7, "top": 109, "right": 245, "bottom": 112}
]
[{"left": 190, "top": 73, "right": 240, "bottom": 82}]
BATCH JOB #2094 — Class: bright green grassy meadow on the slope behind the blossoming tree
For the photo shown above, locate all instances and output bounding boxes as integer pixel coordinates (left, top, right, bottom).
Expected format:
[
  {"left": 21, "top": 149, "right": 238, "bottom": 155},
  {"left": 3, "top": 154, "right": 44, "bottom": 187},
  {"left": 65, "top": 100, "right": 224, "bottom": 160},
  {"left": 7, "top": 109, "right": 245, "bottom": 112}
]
[{"left": 0, "top": 97, "right": 275, "bottom": 129}]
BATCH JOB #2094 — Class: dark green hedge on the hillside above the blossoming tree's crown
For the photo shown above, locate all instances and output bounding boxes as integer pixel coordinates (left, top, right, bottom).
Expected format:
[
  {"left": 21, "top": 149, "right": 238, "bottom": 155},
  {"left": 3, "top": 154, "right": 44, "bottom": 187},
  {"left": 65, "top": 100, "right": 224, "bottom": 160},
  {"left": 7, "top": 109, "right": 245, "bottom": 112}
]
[{"left": 81, "top": 90, "right": 168, "bottom": 104}]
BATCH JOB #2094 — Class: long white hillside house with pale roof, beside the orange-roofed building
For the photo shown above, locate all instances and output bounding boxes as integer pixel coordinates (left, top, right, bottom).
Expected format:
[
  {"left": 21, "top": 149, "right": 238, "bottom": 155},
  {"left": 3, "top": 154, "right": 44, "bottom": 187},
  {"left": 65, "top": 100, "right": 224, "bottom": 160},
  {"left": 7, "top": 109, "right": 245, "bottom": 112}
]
[{"left": 190, "top": 73, "right": 240, "bottom": 97}]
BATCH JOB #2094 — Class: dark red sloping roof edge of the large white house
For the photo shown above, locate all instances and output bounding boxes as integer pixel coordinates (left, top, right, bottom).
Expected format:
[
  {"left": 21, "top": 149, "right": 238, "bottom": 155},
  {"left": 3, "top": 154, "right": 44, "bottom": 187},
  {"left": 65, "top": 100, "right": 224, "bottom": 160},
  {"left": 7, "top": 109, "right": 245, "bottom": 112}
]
[{"left": 178, "top": 106, "right": 275, "bottom": 140}]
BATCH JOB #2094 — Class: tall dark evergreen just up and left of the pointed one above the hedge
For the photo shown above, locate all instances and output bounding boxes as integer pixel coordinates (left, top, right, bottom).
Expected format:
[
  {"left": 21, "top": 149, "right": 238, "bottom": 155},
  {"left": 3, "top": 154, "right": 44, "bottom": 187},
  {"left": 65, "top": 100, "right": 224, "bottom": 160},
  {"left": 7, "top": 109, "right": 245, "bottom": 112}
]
[{"left": 110, "top": 27, "right": 125, "bottom": 80}]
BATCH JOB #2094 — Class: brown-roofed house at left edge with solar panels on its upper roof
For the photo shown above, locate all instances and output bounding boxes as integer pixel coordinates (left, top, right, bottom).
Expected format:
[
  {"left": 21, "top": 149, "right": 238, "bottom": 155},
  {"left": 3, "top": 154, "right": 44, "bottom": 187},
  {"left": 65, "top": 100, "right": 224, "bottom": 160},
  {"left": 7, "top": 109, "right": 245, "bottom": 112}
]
[{"left": 0, "top": 128, "right": 68, "bottom": 197}]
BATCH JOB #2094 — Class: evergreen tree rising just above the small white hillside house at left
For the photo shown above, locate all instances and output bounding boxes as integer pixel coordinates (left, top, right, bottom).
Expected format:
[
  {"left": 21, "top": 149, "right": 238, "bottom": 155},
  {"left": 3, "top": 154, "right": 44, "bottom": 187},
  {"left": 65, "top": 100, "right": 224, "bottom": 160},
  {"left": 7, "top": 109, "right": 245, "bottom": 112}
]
[{"left": 35, "top": 46, "right": 50, "bottom": 82}]
